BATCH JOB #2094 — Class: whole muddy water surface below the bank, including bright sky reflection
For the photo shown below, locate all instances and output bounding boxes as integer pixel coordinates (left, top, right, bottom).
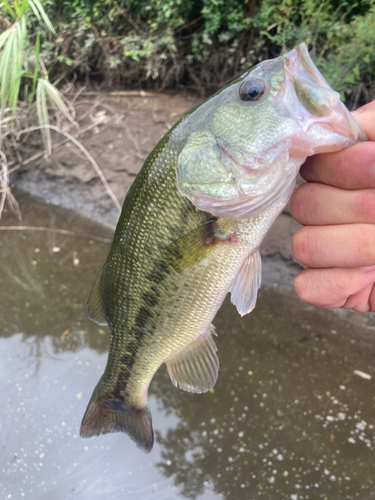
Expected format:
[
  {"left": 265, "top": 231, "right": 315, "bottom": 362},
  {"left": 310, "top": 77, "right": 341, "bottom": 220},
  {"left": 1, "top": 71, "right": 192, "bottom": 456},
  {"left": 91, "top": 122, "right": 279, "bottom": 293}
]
[{"left": 0, "top": 192, "right": 375, "bottom": 500}]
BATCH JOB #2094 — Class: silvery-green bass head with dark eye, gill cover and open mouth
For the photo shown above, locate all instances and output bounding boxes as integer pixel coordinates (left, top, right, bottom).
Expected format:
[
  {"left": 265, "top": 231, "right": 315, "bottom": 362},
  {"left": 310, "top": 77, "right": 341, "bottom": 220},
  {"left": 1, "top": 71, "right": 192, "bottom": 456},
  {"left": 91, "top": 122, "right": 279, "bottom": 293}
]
[{"left": 177, "top": 44, "right": 367, "bottom": 219}]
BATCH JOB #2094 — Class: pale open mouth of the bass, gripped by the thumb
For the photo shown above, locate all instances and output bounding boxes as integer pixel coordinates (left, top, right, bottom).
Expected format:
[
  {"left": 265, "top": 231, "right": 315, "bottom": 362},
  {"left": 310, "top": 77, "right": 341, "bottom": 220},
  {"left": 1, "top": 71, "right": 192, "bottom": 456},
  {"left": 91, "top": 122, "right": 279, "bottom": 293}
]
[{"left": 283, "top": 43, "right": 368, "bottom": 146}]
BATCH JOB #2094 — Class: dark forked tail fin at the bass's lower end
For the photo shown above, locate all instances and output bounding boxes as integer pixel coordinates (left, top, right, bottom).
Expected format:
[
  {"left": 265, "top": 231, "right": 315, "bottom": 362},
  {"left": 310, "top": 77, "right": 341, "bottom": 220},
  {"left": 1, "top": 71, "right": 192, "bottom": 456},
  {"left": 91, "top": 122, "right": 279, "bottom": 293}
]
[{"left": 80, "top": 388, "right": 154, "bottom": 453}]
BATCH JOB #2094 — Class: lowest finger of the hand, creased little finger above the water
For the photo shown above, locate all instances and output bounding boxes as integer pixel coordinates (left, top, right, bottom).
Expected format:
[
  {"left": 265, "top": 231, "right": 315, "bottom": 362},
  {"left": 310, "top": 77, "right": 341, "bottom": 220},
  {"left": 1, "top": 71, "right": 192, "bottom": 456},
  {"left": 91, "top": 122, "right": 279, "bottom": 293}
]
[{"left": 294, "top": 267, "right": 375, "bottom": 312}]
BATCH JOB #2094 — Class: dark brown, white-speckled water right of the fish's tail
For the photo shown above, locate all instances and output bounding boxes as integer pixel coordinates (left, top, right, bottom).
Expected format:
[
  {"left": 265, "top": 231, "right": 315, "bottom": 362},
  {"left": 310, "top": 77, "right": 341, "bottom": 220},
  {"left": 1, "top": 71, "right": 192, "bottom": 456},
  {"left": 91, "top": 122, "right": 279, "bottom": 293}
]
[{"left": 154, "top": 289, "right": 375, "bottom": 500}]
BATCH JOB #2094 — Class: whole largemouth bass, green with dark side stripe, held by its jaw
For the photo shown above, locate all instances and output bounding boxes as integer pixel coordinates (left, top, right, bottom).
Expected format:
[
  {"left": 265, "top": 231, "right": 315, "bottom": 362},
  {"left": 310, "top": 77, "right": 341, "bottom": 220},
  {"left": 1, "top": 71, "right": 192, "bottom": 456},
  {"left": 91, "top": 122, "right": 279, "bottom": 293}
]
[{"left": 80, "top": 44, "right": 367, "bottom": 453}]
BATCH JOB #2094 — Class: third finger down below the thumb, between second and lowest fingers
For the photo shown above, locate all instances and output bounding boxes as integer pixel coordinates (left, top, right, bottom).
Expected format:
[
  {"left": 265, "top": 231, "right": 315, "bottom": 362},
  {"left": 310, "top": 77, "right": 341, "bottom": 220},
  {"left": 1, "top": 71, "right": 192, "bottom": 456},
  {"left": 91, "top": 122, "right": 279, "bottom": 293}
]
[{"left": 292, "top": 224, "right": 375, "bottom": 268}]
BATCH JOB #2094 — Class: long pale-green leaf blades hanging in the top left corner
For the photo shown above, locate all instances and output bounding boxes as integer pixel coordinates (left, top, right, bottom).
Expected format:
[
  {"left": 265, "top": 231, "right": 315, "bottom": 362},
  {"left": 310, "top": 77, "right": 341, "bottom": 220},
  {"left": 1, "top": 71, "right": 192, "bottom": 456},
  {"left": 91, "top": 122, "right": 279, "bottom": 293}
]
[{"left": 0, "top": 0, "right": 73, "bottom": 152}]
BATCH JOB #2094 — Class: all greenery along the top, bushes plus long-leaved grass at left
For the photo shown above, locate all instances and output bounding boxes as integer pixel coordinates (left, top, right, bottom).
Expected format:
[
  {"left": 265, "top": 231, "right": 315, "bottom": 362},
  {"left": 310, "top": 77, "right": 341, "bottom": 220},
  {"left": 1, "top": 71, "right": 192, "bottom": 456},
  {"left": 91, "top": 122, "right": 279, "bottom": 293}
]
[{"left": 0, "top": 0, "right": 375, "bottom": 215}]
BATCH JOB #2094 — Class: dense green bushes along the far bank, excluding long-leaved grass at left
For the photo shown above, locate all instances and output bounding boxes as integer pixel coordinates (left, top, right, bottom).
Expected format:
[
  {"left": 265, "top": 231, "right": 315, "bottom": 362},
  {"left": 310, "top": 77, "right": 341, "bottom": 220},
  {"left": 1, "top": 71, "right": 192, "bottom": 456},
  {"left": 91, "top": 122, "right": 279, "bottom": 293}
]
[{"left": 4, "top": 0, "right": 375, "bottom": 107}]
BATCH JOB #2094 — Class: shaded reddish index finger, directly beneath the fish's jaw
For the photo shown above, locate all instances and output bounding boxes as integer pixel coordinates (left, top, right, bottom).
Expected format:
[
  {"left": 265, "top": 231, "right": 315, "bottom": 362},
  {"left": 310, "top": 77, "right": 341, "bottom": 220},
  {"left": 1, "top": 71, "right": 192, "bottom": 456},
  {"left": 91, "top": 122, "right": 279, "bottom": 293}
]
[{"left": 300, "top": 142, "right": 375, "bottom": 189}]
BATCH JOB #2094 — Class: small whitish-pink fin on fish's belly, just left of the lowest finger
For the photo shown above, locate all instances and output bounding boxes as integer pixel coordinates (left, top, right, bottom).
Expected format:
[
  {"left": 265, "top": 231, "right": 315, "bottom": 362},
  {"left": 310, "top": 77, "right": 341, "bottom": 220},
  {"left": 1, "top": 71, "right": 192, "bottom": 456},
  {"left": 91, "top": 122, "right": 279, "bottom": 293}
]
[{"left": 230, "top": 249, "right": 262, "bottom": 316}]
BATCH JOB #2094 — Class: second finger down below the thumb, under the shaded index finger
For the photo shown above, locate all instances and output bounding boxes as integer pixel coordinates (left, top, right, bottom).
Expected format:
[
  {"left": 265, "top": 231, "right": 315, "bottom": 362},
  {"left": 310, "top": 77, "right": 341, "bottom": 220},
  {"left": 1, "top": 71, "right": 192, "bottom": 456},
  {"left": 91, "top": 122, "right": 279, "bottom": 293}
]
[{"left": 290, "top": 182, "right": 375, "bottom": 226}]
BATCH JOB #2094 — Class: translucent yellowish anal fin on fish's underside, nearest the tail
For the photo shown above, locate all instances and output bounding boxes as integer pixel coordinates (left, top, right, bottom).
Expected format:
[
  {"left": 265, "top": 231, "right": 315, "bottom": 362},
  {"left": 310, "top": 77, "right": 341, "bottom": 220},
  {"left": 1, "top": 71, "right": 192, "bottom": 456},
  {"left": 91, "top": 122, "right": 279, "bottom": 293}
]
[{"left": 166, "top": 325, "right": 219, "bottom": 392}]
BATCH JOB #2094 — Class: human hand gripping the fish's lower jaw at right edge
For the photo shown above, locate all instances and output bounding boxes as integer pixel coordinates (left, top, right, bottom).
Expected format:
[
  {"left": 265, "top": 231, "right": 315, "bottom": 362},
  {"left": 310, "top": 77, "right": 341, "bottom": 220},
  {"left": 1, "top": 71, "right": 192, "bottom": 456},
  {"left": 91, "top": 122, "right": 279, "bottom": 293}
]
[{"left": 291, "top": 101, "right": 375, "bottom": 312}]
